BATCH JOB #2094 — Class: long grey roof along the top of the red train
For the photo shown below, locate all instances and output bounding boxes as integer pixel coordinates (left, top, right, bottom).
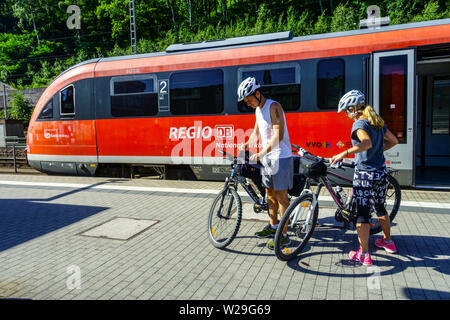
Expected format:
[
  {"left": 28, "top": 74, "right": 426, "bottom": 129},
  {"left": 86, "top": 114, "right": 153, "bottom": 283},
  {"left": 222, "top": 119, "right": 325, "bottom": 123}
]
[{"left": 54, "top": 18, "right": 450, "bottom": 80}]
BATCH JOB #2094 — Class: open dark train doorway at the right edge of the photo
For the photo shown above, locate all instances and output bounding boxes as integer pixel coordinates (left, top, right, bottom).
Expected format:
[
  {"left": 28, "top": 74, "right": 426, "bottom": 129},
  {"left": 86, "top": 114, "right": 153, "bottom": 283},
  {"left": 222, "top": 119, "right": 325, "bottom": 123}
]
[{"left": 416, "top": 59, "right": 450, "bottom": 187}]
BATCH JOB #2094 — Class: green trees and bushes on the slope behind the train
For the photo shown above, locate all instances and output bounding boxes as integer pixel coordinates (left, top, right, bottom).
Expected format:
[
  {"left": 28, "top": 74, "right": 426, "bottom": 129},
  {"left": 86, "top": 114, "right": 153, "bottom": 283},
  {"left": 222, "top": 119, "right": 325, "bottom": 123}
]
[{"left": 0, "top": 0, "right": 450, "bottom": 87}]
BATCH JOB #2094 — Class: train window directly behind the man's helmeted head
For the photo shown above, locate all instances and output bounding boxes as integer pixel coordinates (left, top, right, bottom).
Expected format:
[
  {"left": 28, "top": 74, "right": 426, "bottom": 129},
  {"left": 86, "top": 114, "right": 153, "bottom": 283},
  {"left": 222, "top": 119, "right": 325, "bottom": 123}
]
[{"left": 238, "top": 66, "right": 301, "bottom": 113}]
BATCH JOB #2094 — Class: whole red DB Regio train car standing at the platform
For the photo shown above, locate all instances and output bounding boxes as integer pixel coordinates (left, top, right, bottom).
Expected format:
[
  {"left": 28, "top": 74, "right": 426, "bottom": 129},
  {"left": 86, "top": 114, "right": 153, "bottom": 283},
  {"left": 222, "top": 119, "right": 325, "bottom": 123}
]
[{"left": 27, "top": 19, "right": 450, "bottom": 186}]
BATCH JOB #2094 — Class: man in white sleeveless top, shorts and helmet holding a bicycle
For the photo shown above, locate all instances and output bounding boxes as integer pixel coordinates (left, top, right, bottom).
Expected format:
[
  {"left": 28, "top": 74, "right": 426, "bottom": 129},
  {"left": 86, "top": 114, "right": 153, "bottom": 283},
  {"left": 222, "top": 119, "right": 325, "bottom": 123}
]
[{"left": 238, "top": 77, "right": 294, "bottom": 249}]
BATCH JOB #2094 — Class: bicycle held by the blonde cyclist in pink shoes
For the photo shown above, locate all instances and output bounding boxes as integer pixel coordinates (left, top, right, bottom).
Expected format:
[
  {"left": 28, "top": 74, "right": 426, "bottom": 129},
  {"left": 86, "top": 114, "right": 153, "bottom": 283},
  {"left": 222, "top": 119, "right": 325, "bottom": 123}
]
[{"left": 274, "top": 144, "right": 401, "bottom": 261}]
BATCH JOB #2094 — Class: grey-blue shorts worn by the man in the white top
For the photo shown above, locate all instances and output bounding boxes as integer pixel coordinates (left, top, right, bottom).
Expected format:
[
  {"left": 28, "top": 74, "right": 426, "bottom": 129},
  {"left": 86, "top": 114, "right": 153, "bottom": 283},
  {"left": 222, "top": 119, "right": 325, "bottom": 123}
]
[{"left": 261, "top": 157, "right": 294, "bottom": 191}]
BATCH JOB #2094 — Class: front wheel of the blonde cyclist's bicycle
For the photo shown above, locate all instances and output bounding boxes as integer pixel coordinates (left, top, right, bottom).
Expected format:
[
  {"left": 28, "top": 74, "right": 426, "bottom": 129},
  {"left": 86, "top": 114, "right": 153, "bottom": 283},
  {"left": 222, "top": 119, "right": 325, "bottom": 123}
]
[{"left": 274, "top": 193, "right": 319, "bottom": 261}]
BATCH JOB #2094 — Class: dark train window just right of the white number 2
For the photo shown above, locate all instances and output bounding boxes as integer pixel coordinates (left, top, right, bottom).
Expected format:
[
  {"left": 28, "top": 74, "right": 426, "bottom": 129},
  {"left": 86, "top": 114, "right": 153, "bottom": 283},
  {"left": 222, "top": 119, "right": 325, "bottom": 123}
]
[{"left": 169, "top": 69, "right": 223, "bottom": 115}]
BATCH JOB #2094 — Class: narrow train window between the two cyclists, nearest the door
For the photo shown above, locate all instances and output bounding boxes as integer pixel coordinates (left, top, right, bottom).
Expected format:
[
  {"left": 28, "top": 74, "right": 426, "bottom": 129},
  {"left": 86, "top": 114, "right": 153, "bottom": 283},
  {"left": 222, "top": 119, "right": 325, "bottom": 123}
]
[{"left": 317, "top": 59, "right": 345, "bottom": 109}]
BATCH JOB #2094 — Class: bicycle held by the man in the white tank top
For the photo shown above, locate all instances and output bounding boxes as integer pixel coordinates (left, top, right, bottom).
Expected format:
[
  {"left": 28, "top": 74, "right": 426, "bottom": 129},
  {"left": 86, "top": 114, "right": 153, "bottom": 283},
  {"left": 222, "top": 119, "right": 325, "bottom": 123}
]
[{"left": 208, "top": 150, "right": 306, "bottom": 248}]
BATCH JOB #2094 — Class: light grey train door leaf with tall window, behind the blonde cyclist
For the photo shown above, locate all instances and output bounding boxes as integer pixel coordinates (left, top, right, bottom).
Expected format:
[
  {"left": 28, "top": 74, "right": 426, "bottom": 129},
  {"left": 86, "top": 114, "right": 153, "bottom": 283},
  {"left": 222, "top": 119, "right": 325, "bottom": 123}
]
[{"left": 372, "top": 49, "right": 415, "bottom": 185}]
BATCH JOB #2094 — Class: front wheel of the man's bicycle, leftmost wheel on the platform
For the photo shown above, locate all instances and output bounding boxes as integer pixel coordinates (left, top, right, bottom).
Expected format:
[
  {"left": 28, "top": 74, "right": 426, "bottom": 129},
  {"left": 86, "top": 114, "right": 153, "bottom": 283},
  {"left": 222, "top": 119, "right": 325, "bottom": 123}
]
[{"left": 208, "top": 187, "right": 242, "bottom": 248}]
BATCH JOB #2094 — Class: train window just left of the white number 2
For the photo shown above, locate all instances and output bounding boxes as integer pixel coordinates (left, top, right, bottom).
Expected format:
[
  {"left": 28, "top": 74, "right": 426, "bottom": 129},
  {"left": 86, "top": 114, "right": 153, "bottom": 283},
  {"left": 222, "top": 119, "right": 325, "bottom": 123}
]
[{"left": 111, "top": 76, "right": 158, "bottom": 117}]
